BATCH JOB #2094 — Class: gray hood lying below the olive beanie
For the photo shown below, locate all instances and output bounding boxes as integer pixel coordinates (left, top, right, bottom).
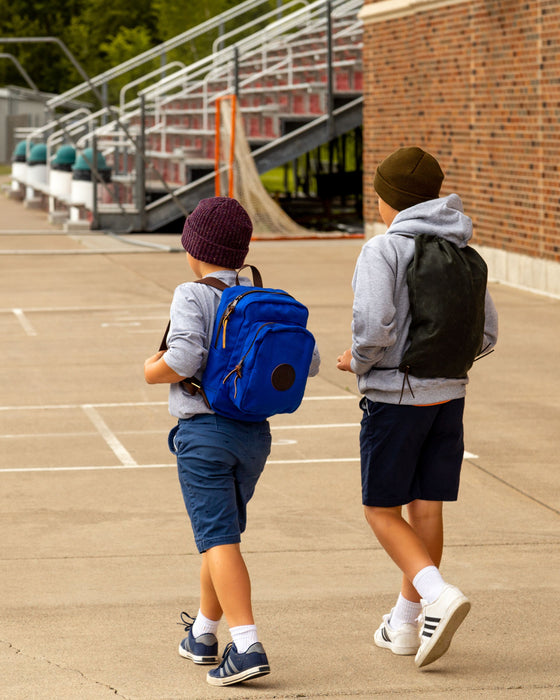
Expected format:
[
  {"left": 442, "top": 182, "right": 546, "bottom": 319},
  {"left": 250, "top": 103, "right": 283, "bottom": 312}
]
[{"left": 386, "top": 194, "right": 472, "bottom": 248}]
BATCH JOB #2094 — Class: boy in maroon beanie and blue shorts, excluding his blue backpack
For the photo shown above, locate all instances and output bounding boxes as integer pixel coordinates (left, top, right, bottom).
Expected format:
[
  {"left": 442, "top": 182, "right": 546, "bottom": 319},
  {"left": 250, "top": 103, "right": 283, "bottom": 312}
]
[{"left": 144, "top": 197, "right": 319, "bottom": 686}]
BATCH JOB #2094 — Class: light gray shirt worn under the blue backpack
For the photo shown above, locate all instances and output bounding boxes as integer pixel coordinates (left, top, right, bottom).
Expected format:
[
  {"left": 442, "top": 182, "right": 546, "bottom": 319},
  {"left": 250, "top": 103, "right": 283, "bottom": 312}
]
[{"left": 163, "top": 270, "right": 320, "bottom": 418}]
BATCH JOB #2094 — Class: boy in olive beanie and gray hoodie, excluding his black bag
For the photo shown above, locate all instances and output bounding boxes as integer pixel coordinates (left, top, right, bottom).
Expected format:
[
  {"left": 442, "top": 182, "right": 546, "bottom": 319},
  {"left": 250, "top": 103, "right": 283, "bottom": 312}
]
[{"left": 337, "top": 146, "right": 497, "bottom": 667}]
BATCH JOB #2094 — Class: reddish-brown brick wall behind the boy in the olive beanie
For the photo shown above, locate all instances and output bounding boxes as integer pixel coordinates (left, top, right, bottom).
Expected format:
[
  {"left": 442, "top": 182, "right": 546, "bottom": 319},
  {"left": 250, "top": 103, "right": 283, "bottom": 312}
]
[{"left": 363, "top": 0, "right": 560, "bottom": 262}]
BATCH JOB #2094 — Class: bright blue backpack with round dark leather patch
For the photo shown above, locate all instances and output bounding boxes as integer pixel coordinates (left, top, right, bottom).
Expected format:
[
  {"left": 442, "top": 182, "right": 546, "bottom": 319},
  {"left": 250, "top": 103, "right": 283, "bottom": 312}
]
[{"left": 161, "top": 265, "right": 315, "bottom": 422}]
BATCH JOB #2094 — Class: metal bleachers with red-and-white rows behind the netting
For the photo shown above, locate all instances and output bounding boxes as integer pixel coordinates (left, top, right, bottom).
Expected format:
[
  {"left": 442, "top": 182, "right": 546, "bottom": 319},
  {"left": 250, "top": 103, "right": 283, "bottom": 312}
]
[{"left": 14, "top": 0, "right": 362, "bottom": 232}]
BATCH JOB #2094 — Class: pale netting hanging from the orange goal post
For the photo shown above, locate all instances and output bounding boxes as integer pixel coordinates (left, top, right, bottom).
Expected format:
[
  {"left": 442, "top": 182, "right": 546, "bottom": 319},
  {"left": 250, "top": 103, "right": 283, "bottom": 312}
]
[{"left": 217, "top": 95, "right": 313, "bottom": 238}]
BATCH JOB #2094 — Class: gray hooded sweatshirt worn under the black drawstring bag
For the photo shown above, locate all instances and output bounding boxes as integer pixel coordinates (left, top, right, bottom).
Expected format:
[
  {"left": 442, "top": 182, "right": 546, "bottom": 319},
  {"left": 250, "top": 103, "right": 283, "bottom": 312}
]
[{"left": 351, "top": 194, "right": 498, "bottom": 405}]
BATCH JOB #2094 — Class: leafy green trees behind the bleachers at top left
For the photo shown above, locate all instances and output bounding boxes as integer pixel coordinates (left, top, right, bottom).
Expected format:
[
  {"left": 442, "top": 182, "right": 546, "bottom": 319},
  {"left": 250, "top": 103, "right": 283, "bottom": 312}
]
[{"left": 0, "top": 0, "right": 279, "bottom": 100}]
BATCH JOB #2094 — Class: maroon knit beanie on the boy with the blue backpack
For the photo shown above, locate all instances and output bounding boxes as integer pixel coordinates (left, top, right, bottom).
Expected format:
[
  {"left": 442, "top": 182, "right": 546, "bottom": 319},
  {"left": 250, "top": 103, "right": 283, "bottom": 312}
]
[{"left": 181, "top": 197, "right": 253, "bottom": 270}]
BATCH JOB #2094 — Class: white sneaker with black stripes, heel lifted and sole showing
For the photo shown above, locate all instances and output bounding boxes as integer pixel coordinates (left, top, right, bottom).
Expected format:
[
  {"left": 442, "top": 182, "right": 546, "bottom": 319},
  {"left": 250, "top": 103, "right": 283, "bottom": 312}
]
[{"left": 414, "top": 584, "right": 471, "bottom": 668}]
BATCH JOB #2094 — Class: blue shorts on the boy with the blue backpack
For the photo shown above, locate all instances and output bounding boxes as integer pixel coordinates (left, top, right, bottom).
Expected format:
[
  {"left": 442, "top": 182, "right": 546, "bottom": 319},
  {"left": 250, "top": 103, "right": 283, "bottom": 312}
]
[{"left": 169, "top": 414, "right": 271, "bottom": 552}]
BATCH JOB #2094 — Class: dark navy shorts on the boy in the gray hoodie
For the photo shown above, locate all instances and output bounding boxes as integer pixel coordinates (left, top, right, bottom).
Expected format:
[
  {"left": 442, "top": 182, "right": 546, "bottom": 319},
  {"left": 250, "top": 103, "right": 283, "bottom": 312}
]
[{"left": 360, "top": 397, "right": 465, "bottom": 508}]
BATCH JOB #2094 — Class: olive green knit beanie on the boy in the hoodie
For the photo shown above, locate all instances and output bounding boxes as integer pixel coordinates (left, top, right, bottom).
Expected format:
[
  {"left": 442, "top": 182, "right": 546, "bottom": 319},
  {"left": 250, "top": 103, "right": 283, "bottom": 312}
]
[{"left": 373, "top": 146, "right": 445, "bottom": 211}]
